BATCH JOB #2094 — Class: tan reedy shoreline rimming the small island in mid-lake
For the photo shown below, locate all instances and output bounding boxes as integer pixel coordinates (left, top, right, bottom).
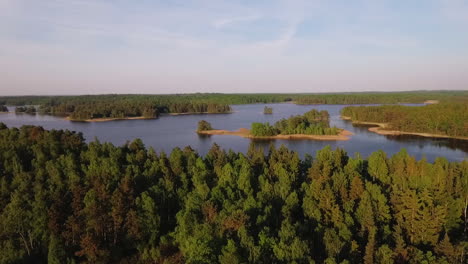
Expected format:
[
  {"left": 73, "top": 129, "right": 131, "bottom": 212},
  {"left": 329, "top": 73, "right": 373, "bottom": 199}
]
[{"left": 197, "top": 128, "right": 353, "bottom": 140}]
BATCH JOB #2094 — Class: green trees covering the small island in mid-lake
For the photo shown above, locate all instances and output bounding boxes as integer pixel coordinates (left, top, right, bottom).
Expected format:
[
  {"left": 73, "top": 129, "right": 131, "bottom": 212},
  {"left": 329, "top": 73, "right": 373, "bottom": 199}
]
[{"left": 250, "top": 109, "right": 341, "bottom": 137}]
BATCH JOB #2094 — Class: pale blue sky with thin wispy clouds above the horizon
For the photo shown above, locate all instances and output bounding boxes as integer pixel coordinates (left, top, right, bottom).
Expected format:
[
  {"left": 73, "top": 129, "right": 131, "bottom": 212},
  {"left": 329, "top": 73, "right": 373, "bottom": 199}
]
[{"left": 0, "top": 0, "right": 468, "bottom": 95}]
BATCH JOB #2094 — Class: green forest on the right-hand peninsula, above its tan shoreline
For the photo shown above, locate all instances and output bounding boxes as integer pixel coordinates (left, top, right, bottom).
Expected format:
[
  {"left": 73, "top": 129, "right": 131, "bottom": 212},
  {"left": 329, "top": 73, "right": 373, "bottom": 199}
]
[{"left": 341, "top": 103, "right": 468, "bottom": 137}]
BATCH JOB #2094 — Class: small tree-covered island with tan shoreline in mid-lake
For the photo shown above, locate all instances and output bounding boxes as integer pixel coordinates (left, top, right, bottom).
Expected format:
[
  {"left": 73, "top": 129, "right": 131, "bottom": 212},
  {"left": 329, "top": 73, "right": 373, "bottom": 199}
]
[{"left": 197, "top": 109, "right": 352, "bottom": 140}]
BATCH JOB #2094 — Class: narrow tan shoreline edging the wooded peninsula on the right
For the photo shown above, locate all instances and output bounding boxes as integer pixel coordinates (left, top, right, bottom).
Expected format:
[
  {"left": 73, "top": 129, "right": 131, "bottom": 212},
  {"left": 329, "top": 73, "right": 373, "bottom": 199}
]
[{"left": 341, "top": 116, "right": 468, "bottom": 140}]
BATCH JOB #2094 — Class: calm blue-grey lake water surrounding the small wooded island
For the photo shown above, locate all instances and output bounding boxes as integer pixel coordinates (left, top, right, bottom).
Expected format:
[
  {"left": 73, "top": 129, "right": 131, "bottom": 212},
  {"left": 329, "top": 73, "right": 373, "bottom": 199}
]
[{"left": 0, "top": 103, "right": 468, "bottom": 162}]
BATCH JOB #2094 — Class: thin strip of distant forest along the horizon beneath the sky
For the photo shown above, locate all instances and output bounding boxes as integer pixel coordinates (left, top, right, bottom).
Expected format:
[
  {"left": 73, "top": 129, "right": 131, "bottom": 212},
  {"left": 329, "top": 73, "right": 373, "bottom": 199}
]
[{"left": 0, "top": 91, "right": 468, "bottom": 107}]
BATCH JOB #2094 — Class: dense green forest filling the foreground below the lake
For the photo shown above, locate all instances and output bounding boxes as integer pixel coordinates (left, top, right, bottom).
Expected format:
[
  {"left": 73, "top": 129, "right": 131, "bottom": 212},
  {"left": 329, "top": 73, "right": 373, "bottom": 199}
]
[{"left": 0, "top": 124, "right": 468, "bottom": 264}]
